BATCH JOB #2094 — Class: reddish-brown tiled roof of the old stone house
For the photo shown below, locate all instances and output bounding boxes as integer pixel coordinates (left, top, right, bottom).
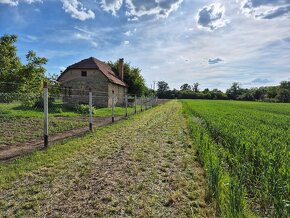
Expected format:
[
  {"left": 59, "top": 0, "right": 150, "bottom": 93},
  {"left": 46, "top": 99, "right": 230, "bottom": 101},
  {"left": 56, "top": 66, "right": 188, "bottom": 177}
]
[{"left": 57, "top": 57, "right": 128, "bottom": 87}]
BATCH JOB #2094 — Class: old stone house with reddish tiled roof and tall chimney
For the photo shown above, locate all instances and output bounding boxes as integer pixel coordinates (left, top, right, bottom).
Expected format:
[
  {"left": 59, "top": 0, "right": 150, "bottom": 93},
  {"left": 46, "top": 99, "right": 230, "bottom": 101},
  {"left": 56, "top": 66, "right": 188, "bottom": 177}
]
[{"left": 57, "top": 57, "right": 128, "bottom": 107}]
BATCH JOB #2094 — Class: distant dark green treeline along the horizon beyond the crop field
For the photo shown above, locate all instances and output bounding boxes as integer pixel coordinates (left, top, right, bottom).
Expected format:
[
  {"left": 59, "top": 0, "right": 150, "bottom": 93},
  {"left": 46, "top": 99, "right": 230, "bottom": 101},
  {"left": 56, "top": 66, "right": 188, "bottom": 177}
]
[{"left": 157, "top": 81, "right": 290, "bottom": 102}]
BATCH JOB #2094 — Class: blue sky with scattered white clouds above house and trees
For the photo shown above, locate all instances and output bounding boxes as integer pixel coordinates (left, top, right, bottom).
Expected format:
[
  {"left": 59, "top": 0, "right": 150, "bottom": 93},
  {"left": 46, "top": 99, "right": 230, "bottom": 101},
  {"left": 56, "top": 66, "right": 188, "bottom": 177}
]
[{"left": 0, "top": 0, "right": 290, "bottom": 90}]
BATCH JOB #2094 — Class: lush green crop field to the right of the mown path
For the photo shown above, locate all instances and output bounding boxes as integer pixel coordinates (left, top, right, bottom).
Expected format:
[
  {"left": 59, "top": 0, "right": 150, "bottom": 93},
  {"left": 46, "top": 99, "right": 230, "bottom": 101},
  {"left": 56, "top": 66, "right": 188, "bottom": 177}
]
[{"left": 182, "top": 100, "right": 290, "bottom": 217}]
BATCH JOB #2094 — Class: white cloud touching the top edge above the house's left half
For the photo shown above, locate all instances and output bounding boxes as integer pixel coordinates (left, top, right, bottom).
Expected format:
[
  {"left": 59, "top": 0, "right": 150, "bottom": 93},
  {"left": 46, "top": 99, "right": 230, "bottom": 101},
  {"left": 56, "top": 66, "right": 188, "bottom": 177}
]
[{"left": 61, "top": 0, "right": 95, "bottom": 21}]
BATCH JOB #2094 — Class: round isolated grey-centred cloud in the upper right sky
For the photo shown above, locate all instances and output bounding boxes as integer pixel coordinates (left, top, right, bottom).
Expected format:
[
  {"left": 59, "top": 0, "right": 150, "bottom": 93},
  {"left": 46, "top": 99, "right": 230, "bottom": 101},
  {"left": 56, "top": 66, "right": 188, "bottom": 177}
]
[{"left": 196, "top": 3, "right": 230, "bottom": 31}]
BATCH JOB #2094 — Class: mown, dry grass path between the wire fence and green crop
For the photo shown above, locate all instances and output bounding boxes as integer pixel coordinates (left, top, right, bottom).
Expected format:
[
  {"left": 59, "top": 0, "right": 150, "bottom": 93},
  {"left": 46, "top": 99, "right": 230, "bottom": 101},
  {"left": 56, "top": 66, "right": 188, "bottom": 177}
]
[{"left": 0, "top": 101, "right": 214, "bottom": 217}]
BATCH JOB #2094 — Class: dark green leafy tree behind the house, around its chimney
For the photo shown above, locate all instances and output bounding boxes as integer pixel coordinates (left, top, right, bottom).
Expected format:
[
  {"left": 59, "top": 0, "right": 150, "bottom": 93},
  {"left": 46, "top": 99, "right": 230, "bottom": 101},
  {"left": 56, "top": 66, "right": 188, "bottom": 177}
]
[{"left": 107, "top": 60, "right": 147, "bottom": 96}]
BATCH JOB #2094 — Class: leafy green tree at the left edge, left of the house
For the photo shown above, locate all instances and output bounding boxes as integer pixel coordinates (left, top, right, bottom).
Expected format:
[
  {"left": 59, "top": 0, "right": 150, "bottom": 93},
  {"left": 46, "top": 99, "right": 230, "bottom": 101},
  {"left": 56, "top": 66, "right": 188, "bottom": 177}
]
[{"left": 0, "top": 35, "right": 47, "bottom": 93}]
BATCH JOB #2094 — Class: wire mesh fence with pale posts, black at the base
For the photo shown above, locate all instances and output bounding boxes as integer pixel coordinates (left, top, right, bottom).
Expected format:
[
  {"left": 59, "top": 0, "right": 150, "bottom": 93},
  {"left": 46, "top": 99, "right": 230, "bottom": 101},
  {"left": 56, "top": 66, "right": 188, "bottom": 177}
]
[{"left": 0, "top": 84, "right": 157, "bottom": 159}]
